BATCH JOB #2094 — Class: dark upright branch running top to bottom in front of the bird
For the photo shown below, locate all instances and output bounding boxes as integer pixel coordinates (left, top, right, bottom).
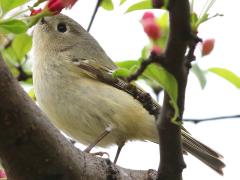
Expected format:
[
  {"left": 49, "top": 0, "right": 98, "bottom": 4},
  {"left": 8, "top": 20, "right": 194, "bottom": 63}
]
[{"left": 157, "top": 0, "right": 191, "bottom": 180}]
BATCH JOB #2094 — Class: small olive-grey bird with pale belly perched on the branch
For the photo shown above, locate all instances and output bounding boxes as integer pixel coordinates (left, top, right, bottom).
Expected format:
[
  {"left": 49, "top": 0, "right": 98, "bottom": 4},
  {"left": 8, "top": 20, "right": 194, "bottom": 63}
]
[{"left": 33, "top": 14, "right": 224, "bottom": 174}]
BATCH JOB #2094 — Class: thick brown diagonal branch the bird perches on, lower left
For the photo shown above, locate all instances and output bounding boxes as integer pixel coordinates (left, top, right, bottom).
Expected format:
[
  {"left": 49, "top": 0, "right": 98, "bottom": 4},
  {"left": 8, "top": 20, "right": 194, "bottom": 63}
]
[{"left": 0, "top": 57, "right": 156, "bottom": 180}]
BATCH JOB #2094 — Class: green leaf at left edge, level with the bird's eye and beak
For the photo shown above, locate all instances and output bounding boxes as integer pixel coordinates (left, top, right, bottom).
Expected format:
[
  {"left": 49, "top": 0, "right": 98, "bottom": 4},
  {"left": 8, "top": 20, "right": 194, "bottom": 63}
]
[{"left": 0, "top": 19, "right": 28, "bottom": 34}]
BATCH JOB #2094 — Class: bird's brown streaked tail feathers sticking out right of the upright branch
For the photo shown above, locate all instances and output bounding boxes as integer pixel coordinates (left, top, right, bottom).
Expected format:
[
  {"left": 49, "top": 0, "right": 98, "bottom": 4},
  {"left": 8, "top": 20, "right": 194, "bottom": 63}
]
[{"left": 150, "top": 129, "right": 225, "bottom": 175}]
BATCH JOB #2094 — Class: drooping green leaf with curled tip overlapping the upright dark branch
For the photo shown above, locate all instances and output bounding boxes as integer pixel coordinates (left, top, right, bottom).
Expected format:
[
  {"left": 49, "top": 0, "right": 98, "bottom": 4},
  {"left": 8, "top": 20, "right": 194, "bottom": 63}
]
[{"left": 143, "top": 64, "right": 180, "bottom": 125}]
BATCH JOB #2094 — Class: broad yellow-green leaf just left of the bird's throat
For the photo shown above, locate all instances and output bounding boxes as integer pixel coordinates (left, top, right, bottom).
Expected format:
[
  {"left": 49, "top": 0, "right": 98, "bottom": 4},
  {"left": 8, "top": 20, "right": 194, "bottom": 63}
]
[{"left": 12, "top": 33, "right": 32, "bottom": 61}]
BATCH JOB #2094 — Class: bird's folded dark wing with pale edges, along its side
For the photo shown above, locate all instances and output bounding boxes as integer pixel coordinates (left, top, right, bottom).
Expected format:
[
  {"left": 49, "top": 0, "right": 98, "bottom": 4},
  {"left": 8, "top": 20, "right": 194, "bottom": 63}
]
[{"left": 68, "top": 58, "right": 161, "bottom": 116}]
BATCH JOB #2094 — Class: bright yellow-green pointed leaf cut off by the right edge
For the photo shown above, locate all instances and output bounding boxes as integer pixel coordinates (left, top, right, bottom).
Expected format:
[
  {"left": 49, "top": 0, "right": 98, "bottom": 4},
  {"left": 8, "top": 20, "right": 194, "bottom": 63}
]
[{"left": 208, "top": 68, "right": 240, "bottom": 88}]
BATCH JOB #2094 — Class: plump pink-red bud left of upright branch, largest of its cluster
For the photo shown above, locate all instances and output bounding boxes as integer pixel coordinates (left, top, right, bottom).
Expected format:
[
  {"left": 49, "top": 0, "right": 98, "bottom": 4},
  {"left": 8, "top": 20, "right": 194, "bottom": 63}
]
[{"left": 142, "top": 19, "right": 161, "bottom": 40}]
